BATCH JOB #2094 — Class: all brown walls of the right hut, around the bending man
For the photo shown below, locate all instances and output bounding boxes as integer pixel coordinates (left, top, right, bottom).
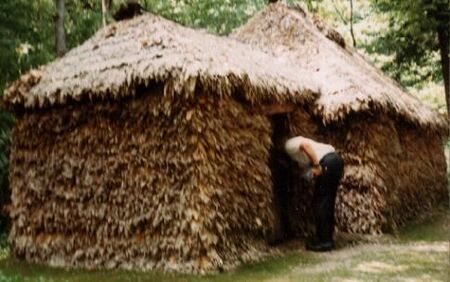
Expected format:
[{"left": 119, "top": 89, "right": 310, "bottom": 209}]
[{"left": 287, "top": 110, "right": 448, "bottom": 235}]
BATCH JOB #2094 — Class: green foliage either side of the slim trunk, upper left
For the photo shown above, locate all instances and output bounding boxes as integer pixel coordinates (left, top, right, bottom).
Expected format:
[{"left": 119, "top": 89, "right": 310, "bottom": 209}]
[{"left": 0, "top": 0, "right": 101, "bottom": 93}]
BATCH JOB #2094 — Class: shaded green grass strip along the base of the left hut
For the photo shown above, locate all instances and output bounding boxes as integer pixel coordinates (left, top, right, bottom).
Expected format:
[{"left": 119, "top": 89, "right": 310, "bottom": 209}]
[{"left": 0, "top": 252, "right": 320, "bottom": 282}]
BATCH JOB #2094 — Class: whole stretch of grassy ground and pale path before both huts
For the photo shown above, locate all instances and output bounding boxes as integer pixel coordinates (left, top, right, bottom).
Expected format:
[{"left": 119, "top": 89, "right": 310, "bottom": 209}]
[{"left": 0, "top": 212, "right": 449, "bottom": 282}]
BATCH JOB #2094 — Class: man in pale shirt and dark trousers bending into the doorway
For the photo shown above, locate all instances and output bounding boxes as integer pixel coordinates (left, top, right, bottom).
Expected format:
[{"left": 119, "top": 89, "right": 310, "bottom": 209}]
[{"left": 285, "top": 136, "right": 344, "bottom": 252}]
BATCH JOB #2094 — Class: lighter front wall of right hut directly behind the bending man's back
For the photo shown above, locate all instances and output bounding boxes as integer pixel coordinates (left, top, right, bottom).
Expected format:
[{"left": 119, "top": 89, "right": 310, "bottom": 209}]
[{"left": 327, "top": 116, "right": 398, "bottom": 234}]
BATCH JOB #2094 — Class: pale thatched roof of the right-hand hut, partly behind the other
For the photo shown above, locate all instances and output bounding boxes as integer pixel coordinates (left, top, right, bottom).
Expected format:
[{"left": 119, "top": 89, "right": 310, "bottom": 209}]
[{"left": 231, "top": 3, "right": 446, "bottom": 132}]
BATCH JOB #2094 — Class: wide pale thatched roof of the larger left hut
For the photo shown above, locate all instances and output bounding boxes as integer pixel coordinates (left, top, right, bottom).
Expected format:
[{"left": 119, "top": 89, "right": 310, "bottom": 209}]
[{"left": 4, "top": 13, "right": 317, "bottom": 108}]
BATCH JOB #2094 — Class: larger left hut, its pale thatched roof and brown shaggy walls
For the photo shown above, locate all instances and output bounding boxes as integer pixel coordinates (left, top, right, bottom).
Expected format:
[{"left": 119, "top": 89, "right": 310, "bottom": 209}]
[{"left": 4, "top": 14, "right": 317, "bottom": 272}]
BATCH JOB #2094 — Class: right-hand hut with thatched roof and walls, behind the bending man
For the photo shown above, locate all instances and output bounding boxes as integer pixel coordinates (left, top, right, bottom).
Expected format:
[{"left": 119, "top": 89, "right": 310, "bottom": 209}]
[{"left": 232, "top": 3, "right": 448, "bottom": 234}]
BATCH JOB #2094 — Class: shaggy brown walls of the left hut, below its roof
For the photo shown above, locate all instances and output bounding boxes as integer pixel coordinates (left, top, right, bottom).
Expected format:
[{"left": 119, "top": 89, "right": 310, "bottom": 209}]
[{"left": 9, "top": 90, "right": 273, "bottom": 272}]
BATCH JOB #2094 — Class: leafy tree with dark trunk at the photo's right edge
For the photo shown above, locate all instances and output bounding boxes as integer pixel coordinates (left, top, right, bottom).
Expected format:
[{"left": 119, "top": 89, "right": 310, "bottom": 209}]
[{"left": 372, "top": 0, "right": 450, "bottom": 117}]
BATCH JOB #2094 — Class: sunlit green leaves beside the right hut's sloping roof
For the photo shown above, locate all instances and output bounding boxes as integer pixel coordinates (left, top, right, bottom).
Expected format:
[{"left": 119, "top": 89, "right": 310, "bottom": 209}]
[{"left": 364, "top": 0, "right": 449, "bottom": 86}]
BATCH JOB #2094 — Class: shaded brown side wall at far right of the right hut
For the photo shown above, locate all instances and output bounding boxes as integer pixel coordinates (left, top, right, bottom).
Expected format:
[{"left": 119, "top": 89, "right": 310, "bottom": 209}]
[{"left": 388, "top": 124, "right": 448, "bottom": 228}]
